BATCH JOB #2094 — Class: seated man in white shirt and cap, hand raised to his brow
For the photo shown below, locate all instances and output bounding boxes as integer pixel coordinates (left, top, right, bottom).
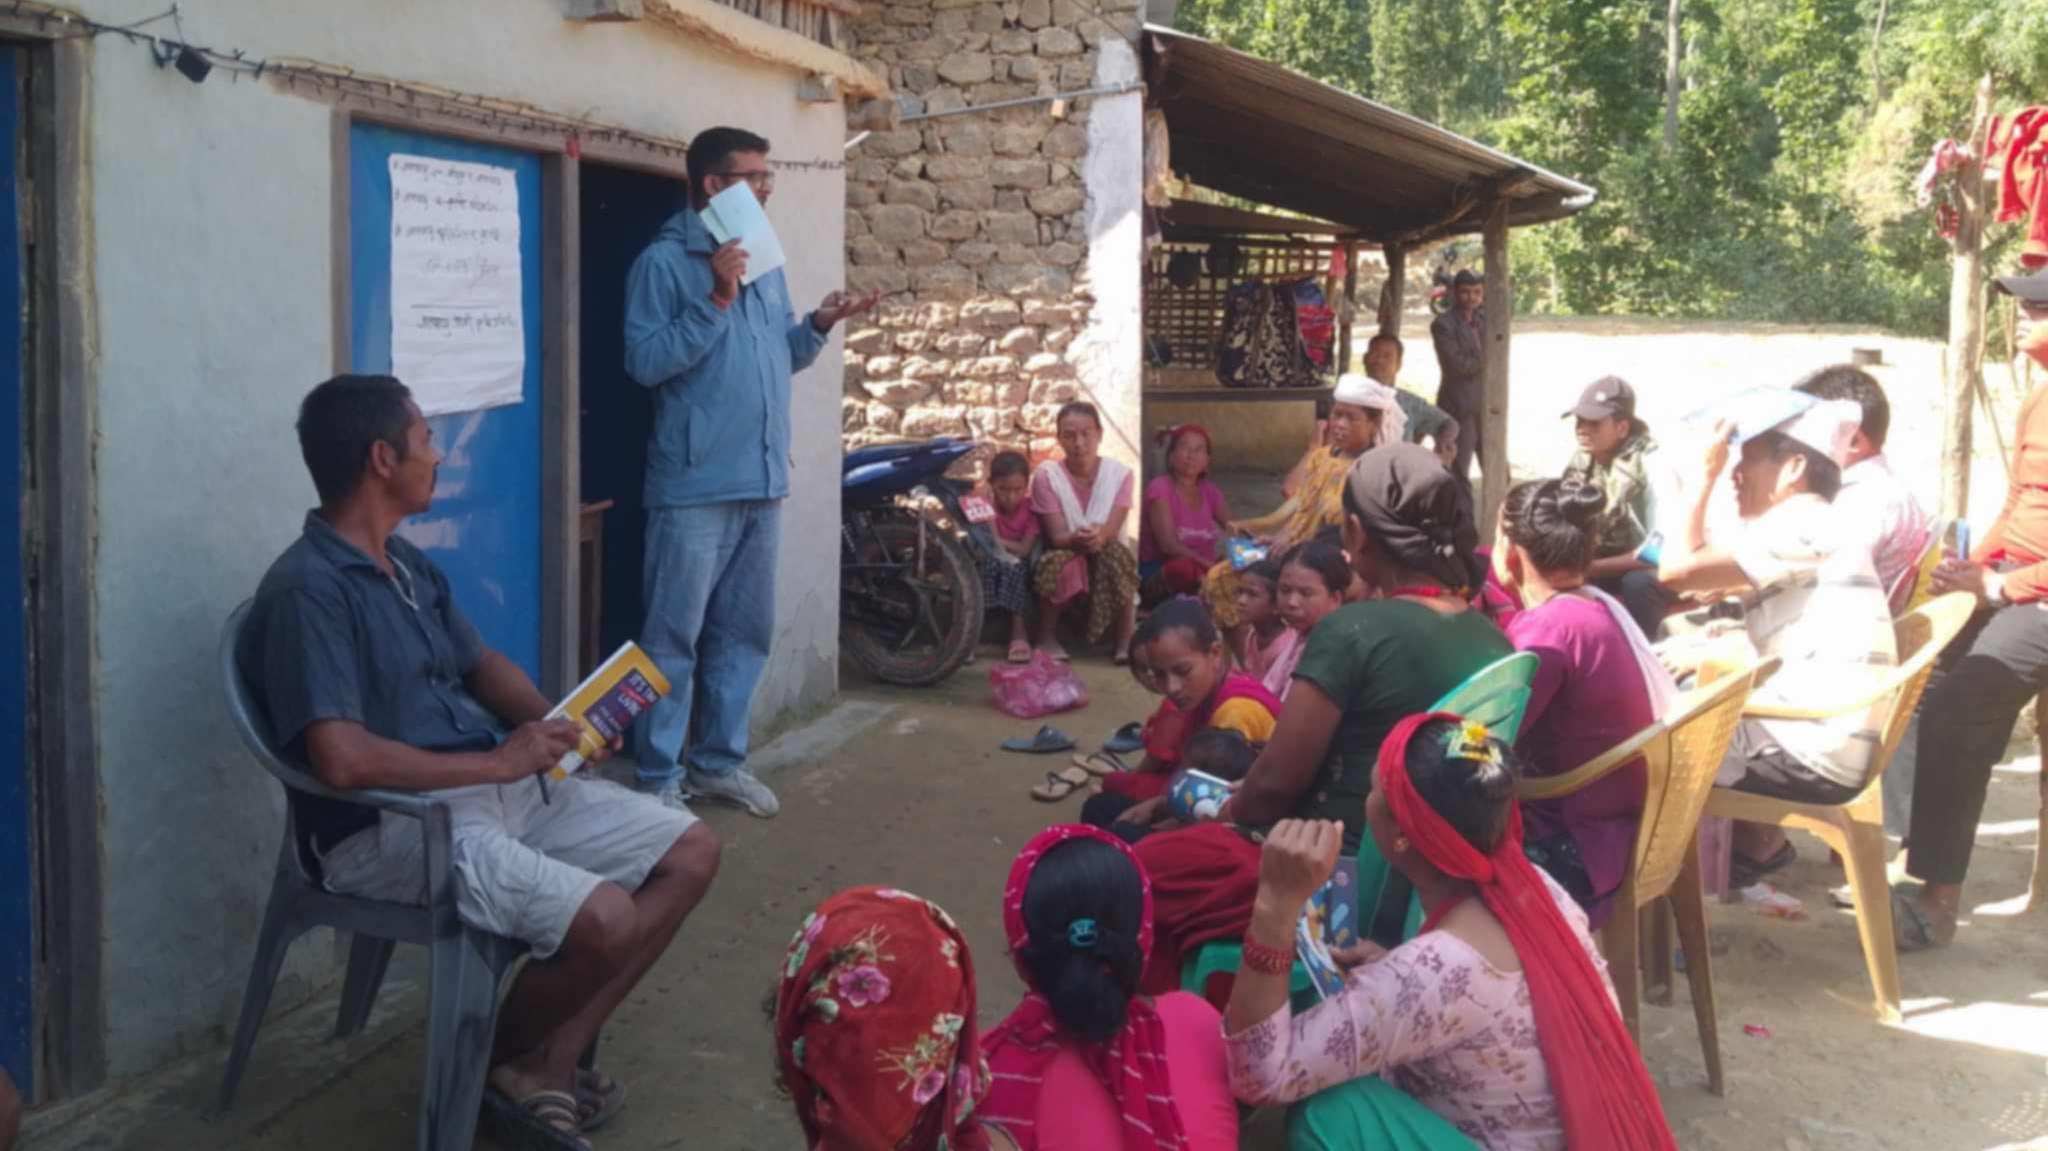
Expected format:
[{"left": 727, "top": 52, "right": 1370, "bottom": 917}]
[{"left": 1659, "top": 397, "right": 1898, "bottom": 887}]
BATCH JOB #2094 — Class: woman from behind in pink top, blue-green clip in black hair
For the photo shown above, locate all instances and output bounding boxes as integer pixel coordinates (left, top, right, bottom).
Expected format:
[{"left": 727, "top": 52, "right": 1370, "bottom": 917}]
[{"left": 979, "top": 823, "right": 1237, "bottom": 1151}]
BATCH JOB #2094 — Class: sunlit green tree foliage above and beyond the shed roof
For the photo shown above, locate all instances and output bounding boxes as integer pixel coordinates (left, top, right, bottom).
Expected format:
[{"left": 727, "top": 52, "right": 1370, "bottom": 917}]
[{"left": 1180, "top": 0, "right": 2048, "bottom": 332}]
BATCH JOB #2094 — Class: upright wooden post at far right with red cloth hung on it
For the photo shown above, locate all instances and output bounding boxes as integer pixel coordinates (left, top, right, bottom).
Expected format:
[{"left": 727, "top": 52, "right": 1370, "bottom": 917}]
[{"left": 1942, "top": 74, "right": 1993, "bottom": 518}]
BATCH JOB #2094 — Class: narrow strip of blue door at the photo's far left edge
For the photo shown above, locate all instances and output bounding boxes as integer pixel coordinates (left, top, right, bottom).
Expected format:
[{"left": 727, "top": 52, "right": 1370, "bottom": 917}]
[{"left": 0, "top": 47, "right": 35, "bottom": 1098}]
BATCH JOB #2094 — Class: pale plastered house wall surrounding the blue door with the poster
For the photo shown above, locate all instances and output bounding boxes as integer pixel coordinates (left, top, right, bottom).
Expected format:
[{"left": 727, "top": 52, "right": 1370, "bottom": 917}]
[{"left": 78, "top": 0, "right": 844, "bottom": 1077}]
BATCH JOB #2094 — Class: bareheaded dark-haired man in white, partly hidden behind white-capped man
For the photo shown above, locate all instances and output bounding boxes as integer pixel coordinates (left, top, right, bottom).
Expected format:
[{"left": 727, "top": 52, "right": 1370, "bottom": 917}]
[{"left": 1794, "top": 365, "right": 1933, "bottom": 614}]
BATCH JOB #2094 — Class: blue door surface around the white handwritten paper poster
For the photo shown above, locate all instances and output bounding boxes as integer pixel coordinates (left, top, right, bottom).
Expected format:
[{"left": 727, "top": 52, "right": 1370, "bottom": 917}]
[{"left": 348, "top": 125, "right": 541, "bottom": 682}]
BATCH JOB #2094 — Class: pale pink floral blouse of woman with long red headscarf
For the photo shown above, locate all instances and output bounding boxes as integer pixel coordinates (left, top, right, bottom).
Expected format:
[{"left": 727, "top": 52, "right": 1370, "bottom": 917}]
[{"left": 1227, "top": 877, "right": 1614, "bottom": 1151}]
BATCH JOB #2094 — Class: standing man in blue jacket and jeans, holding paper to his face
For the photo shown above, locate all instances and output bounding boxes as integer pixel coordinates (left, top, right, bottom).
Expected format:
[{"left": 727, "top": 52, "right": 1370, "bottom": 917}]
[{"left": 625, "top": 127, "right": 877, "bottom": 819}]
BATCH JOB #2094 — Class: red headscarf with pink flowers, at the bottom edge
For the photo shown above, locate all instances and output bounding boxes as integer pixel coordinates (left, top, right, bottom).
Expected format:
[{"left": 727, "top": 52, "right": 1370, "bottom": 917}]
[{"left": 774, "top": 887, "right": 989, "bottom": 1151}]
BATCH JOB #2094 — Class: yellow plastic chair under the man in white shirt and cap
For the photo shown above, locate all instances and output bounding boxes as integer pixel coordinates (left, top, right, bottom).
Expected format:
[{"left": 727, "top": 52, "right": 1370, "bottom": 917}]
[{"left": 1686, "top": 592, "right": 1976, "bottom": 1022}]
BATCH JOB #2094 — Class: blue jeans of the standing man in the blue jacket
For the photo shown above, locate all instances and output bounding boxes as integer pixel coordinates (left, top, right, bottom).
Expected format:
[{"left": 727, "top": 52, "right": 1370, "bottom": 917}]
[{"left": 635, "top": 500, "right": 782, "bottom": 788}]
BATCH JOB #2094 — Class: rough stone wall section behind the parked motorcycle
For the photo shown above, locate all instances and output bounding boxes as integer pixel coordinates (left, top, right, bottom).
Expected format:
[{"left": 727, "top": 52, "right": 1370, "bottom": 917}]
[{"left": 842, "top": 0, "right": 1141, "bottom": 455}]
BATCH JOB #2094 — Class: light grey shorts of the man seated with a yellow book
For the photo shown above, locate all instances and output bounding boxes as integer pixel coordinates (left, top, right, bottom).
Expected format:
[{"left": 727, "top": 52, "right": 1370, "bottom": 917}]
[{"left": 322, "top": 774, "right": 696, "bottom": 958}]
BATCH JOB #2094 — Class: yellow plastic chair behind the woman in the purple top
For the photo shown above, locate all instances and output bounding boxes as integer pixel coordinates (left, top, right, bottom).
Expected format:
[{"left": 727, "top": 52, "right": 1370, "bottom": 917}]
[{"left": 1516, "top": 659, "right": 1778, "bottom": 1096}]
